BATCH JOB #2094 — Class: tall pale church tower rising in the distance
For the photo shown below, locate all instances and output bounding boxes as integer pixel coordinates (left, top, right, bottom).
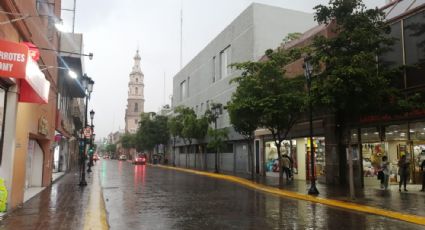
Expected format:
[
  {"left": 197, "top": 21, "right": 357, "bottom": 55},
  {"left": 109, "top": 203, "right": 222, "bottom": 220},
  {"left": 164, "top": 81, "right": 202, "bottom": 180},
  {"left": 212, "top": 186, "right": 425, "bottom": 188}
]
[{"left": 125, "top": 50, "right": 145, "bottom": 133}]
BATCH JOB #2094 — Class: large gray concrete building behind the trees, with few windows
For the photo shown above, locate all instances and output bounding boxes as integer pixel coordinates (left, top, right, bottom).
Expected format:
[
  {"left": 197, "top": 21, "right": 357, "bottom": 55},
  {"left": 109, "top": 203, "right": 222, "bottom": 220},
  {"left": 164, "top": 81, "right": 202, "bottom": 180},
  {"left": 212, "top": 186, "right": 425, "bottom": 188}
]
[{"left": 170, "top": 3, "right": 316, "bottom": 173}]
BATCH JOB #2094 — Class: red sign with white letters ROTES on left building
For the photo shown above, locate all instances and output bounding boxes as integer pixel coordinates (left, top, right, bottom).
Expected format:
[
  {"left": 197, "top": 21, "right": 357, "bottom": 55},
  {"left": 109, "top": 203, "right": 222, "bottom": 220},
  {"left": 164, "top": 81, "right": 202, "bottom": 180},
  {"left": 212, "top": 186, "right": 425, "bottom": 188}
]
[{"left": 0, "top": 39, "right": 28, "bottom": 78}]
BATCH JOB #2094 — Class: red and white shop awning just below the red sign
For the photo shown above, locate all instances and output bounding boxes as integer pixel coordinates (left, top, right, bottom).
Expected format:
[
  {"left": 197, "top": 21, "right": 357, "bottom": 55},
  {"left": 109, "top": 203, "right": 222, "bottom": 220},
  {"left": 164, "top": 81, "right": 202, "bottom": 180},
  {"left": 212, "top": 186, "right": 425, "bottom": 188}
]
[{"left": 19, "top": 58, "right": 50, "bottom": 104}]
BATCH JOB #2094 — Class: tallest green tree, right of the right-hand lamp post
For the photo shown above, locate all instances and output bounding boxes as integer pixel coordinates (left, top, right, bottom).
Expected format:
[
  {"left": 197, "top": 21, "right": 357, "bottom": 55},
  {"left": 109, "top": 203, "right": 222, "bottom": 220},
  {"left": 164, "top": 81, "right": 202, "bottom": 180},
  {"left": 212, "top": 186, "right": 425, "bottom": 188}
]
[{"left": 312, "top": 0, "right": 422, "bottom": 196}]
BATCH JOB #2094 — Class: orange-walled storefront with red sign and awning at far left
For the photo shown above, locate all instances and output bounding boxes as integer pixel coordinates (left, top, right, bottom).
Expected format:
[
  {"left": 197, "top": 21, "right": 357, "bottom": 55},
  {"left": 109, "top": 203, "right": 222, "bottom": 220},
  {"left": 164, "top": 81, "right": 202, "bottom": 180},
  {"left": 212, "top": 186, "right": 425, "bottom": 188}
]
[{"left": 0, "top": 40, "right": 52, "bottom": 208}]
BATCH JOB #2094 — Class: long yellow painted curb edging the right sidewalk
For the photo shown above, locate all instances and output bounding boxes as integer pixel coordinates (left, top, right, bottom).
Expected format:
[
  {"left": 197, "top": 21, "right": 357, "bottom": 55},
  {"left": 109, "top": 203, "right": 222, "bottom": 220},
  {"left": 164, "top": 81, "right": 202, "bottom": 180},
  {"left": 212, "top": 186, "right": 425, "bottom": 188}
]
[{"left": 157, "top": 165, "right": 425, "bottom": 225}]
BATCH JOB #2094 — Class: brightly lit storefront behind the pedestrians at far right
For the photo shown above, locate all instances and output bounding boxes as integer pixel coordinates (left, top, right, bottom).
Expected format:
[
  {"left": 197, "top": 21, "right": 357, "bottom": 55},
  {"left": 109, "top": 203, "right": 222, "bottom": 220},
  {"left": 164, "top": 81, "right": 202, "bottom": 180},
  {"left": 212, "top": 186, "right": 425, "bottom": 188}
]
[{"left": 352, "top": 122, "right": 425, "bottom": 186}]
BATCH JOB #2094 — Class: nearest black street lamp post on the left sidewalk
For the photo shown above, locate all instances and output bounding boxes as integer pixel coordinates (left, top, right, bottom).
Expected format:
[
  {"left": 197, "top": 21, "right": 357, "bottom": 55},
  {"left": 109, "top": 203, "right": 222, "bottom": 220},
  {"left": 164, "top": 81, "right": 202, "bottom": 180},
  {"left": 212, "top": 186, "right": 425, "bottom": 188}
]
[{"left": 80, "top": 74, "right": 94, "bottom": 186}]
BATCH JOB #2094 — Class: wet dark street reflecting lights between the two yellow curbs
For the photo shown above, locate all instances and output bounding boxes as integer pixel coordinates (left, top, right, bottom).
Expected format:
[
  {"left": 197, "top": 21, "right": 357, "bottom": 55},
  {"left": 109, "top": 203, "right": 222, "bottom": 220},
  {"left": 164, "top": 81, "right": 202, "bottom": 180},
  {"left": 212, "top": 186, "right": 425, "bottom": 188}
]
[{"left": 98, "top": 160, "right": 423, "bottom": 230}]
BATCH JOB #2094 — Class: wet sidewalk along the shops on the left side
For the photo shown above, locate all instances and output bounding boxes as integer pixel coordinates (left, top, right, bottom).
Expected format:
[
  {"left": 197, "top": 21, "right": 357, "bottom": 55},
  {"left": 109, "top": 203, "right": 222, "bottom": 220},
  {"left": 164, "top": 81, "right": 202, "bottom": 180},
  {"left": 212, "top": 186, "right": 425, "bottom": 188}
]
[{"left": 0, "top": 167, "right": 107, "bottom": 230}]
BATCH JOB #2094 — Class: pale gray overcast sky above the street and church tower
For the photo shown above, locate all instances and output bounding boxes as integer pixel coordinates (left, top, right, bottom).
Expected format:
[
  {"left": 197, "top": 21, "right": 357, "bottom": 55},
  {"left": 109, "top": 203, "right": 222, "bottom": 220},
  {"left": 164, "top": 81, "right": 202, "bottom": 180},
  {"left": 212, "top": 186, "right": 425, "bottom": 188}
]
[{"left": 58, "top": 0, "right": 385, "bottom": 138}]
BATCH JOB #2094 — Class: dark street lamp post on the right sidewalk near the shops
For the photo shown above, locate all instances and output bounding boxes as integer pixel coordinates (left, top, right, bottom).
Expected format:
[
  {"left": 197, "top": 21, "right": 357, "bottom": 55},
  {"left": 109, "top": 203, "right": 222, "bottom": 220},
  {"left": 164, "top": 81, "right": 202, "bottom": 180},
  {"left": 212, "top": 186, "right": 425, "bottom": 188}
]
[{"left": 304, "top": 56, "right": 319, "bottom": 195}]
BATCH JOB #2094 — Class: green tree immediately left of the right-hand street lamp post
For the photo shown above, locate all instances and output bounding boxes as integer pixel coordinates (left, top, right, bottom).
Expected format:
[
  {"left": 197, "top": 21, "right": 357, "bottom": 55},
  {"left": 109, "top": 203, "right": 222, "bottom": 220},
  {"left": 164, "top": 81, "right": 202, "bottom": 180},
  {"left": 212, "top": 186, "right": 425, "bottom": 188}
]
[{"left": 230, "top": 48, "right": 306, "bottom": 184}]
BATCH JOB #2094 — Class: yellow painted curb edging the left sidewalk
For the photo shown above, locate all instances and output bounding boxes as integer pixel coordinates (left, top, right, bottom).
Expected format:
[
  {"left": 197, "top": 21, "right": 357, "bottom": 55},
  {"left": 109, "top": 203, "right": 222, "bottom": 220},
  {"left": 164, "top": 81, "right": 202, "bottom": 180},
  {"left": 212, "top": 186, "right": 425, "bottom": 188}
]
[{"left": 84, "top": 169, "right": 109, "bottom": 230}]
